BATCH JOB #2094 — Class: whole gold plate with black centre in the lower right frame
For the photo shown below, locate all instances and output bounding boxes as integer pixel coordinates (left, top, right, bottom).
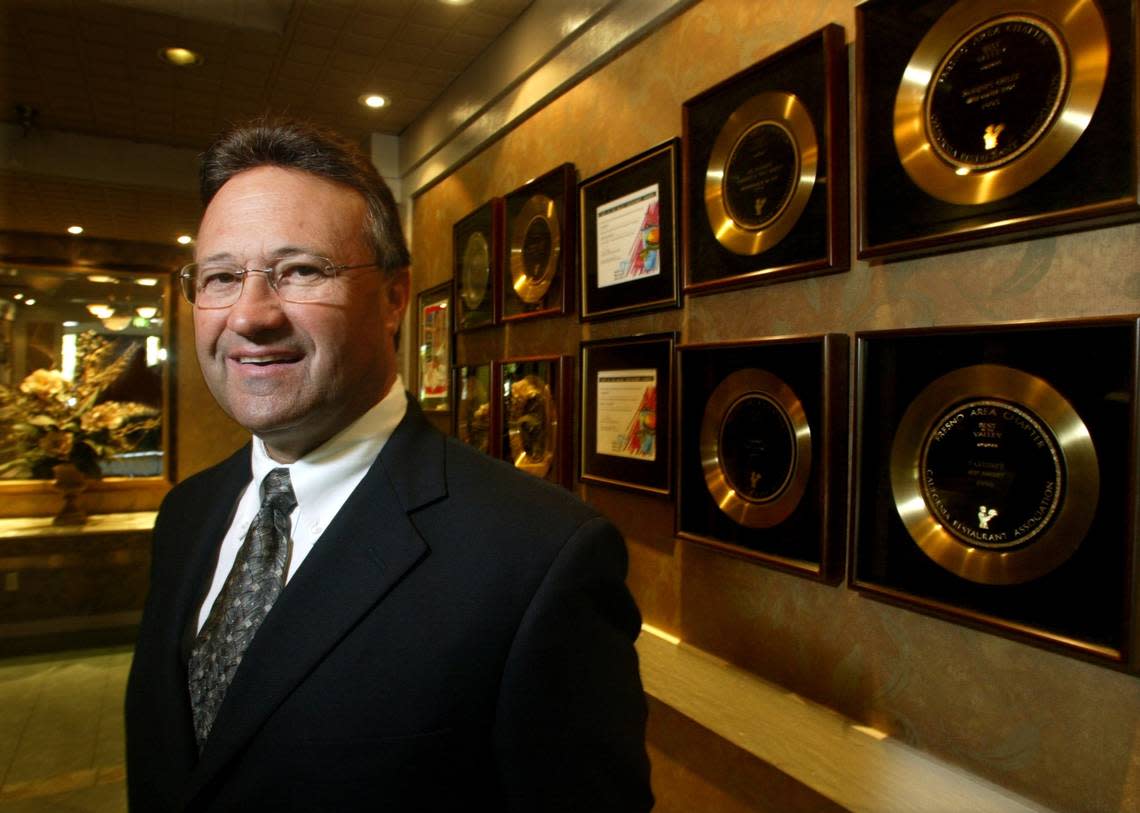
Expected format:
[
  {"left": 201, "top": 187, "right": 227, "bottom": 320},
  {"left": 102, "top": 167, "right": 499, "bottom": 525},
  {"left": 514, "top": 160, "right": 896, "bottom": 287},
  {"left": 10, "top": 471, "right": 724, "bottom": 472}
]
[{"left": 890, "top": 364, "right": 1100, "bottom": 585}]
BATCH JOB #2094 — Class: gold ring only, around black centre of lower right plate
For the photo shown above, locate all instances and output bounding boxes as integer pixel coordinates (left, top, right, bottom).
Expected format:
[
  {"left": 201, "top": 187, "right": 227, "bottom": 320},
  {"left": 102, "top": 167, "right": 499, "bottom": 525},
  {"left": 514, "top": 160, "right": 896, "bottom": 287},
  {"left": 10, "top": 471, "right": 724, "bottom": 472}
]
[{"left": 890, "top": 364, "right": 1100, "bottom": 585}]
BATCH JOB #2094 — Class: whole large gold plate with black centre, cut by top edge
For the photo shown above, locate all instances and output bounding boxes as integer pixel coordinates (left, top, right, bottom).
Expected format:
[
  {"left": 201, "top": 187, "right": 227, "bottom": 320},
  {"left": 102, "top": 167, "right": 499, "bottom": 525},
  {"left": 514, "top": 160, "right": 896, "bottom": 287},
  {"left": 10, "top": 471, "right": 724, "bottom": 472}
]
[{"left": 895, "top": 0, "right": 1109, "bottom": 205}]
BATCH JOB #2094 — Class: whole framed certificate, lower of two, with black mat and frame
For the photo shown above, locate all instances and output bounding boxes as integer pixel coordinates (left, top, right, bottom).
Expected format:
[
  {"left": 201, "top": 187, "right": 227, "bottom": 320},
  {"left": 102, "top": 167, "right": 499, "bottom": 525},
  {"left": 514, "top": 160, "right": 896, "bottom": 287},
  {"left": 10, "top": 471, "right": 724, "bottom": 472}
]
[{"left": 578, "top": 333, "right": 677, "bottom": 496}]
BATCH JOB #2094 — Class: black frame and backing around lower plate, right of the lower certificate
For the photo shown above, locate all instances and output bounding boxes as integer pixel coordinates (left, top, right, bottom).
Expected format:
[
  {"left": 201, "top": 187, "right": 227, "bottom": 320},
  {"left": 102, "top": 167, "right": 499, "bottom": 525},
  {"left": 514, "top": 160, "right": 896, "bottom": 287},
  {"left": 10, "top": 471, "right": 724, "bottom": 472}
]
[{"left": 677, "top": 334, "right": 848, "bottom": 582}]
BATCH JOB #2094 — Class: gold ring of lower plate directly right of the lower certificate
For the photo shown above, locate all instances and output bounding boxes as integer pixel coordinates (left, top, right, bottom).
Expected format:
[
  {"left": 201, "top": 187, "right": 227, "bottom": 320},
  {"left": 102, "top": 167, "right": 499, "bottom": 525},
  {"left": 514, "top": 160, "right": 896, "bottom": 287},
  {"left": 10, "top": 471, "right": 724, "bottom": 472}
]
[{"left": 700, "top": 367, "right": 812, "bottom": 528}]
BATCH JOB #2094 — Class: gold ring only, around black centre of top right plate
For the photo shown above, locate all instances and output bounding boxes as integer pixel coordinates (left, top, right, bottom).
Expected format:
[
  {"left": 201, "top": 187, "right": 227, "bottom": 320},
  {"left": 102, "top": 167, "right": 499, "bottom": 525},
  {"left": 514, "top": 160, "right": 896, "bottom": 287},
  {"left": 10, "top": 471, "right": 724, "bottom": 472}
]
[{"left": 894, "top": 0, "right": 1109, "bottom": 205}]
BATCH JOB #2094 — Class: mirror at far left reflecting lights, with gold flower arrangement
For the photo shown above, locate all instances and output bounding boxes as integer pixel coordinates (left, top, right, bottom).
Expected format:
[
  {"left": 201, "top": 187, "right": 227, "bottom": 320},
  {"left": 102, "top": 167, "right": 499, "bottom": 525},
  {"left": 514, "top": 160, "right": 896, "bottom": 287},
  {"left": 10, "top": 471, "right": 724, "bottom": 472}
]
[{"left": 0, "top": 266, "right": 166, "bottom": 481}]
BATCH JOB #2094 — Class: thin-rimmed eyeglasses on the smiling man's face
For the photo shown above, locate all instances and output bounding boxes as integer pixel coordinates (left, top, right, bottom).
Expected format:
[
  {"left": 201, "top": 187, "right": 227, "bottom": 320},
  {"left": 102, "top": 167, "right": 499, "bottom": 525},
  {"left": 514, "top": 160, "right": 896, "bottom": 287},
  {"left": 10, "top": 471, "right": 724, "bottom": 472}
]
[{"left": 178, "top": 254, "right": 377, "bottom": 309}]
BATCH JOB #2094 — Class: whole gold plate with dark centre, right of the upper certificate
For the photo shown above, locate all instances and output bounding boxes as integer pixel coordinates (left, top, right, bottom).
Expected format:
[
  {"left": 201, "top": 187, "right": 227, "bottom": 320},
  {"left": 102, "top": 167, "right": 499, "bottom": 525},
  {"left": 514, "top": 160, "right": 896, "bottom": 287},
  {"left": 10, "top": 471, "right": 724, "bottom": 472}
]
[{"left": 705, "top": 91, "right": 820, "bottom": 255}]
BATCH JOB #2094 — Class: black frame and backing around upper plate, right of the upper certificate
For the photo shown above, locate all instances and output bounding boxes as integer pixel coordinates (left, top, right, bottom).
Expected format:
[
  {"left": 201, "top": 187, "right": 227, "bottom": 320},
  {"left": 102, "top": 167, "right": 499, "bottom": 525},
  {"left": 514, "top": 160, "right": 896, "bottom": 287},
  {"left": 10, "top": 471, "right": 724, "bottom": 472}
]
[{"left": 682, "top": 24, "right": 850, "bottom": 293}]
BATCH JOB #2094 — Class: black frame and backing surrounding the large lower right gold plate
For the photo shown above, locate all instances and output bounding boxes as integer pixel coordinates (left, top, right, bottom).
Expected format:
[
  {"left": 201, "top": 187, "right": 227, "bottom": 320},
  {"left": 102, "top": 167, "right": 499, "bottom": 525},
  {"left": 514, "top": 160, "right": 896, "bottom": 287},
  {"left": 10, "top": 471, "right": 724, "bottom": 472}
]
[{"left": 849, "top": 317, "right": 1138, "bottom": 661}]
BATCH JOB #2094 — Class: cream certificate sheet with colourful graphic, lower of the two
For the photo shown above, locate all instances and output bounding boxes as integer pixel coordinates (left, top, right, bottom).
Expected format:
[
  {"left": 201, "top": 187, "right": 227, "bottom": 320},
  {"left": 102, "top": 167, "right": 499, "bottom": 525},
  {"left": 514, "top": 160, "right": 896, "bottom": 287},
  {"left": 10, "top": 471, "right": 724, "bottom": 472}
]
[{"left": 597, "top": 369, "right": 657, "bottom": 461}]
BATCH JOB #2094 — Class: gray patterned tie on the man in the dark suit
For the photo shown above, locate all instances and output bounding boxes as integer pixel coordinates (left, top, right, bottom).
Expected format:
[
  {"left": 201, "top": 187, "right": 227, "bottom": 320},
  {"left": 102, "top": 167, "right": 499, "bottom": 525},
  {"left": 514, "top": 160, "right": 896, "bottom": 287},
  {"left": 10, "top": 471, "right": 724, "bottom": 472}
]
[{"left": 188, "top": 469, "right": 296, "bottom": 749}]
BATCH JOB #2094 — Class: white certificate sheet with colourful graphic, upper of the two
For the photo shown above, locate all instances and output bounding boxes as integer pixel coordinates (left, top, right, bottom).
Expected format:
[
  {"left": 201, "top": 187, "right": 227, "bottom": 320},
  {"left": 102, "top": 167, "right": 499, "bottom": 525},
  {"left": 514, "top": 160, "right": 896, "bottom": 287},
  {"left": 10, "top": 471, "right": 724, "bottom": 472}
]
[{"left": 597, "top": 184, "right": 661, "bottom": 288}]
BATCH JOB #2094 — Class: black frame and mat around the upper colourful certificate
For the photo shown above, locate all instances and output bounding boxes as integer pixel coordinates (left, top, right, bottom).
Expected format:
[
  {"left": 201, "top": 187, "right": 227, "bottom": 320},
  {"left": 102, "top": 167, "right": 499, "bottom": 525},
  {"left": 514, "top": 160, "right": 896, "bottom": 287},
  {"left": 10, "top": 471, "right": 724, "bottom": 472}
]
[{"left": 578, "top": 138, "right": 681, "bottom": 322}]
